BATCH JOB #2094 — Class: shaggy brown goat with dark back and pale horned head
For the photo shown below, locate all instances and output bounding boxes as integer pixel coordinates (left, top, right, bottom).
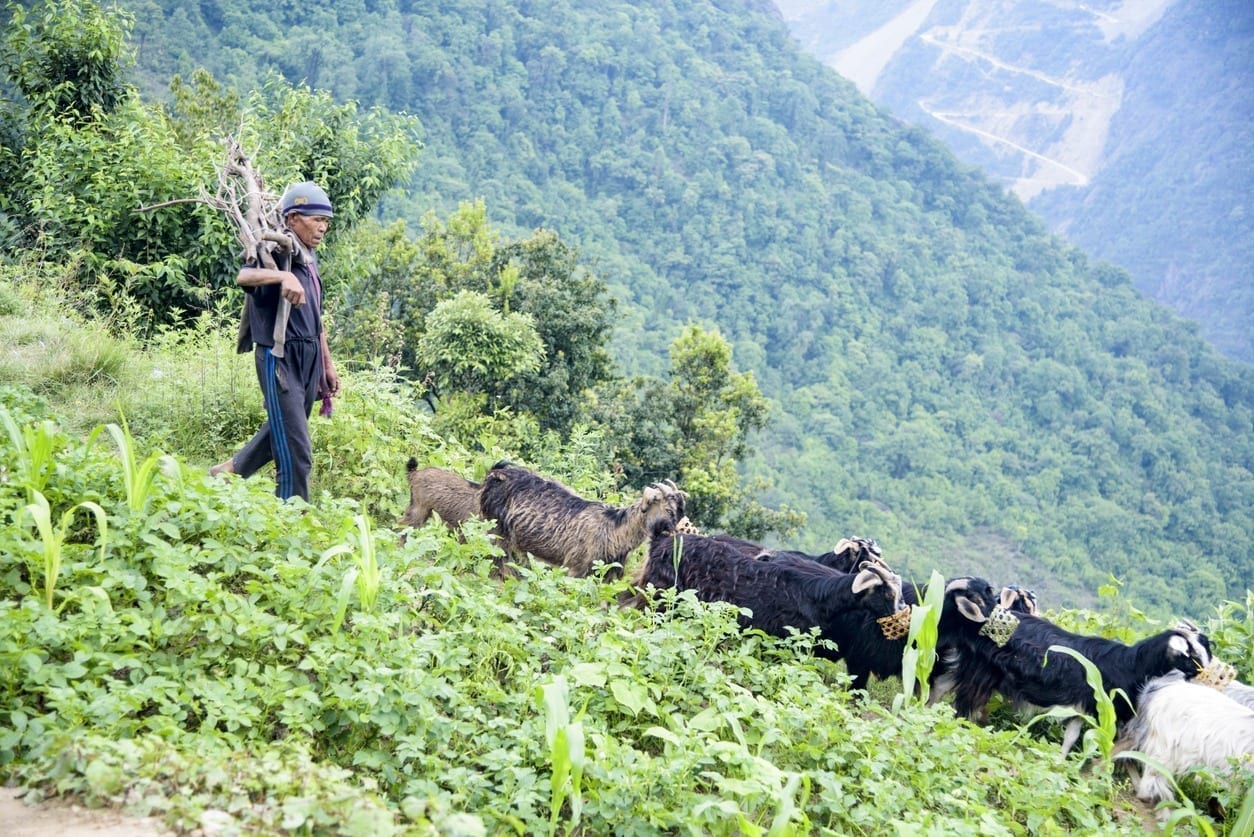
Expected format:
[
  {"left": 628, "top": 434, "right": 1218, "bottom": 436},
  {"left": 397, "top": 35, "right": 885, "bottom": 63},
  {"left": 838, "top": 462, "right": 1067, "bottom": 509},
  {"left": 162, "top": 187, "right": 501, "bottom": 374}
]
[{"left": 479, "top": 461, "right": 685, "bottom": 581}]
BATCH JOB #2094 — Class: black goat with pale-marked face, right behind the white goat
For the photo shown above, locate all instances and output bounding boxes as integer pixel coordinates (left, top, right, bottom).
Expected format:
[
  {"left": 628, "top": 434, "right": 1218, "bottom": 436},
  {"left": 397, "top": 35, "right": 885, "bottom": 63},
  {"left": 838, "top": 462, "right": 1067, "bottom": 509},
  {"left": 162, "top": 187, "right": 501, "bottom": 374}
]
[{"left": 949, "top": 614, "right": 1210, "bottom": 754}]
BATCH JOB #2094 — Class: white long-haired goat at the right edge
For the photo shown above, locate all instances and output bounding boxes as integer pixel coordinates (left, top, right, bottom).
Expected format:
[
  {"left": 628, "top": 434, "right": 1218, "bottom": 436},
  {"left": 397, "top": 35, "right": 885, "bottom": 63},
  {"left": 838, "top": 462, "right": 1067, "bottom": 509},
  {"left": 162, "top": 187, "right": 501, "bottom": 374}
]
[{"left": 1115, "top": 671, "right": 1254, "bottom": 803}]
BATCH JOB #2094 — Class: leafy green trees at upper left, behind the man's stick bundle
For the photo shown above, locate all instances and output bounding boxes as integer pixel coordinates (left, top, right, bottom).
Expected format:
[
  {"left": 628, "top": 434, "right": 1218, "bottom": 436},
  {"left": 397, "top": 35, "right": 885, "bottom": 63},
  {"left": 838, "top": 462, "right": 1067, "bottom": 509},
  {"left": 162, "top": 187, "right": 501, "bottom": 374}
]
[{"left": 0, "top": 0, "right": 419, "bottom": 329}]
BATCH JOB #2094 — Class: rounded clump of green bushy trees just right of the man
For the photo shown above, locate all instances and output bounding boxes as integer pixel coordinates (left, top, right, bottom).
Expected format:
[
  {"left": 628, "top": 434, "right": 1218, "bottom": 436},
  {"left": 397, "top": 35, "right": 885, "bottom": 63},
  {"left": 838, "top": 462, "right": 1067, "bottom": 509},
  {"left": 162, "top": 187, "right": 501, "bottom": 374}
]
[{"left": 323, "top": 201, "right": 616, "bottom": 435}]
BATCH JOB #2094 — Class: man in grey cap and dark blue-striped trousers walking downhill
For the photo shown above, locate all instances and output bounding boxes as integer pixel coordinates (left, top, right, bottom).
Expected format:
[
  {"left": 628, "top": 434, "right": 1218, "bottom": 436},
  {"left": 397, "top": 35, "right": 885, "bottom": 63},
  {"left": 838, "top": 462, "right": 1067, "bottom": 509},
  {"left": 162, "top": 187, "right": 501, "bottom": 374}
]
[{"left": 209, "top": 181, "right": 340, "bottom": 502}]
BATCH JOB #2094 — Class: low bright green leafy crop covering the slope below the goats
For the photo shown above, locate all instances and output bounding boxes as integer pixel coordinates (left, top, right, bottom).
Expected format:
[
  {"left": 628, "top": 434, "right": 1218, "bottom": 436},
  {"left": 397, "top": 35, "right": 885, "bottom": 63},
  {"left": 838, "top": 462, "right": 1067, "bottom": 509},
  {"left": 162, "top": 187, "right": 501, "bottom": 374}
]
[{"left": 0, "top": 302, "right": 1254, "bottom": 834}]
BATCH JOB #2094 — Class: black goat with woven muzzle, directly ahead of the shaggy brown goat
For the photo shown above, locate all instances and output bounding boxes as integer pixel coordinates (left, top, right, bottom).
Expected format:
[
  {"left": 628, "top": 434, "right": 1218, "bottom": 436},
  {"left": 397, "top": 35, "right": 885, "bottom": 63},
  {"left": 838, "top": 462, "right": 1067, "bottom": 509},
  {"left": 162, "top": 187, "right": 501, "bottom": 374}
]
[{"left": 633, "top": 526, "right": 905, "bottom": 688}]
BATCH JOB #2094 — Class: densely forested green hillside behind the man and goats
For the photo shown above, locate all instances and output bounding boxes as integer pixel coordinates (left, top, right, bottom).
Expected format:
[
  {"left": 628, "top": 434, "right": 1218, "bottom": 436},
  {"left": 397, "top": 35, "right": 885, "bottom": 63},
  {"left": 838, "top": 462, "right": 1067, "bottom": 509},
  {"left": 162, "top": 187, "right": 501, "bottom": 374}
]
[{"left": 63, "top": 0, "right": 1254, "bottom": 612}]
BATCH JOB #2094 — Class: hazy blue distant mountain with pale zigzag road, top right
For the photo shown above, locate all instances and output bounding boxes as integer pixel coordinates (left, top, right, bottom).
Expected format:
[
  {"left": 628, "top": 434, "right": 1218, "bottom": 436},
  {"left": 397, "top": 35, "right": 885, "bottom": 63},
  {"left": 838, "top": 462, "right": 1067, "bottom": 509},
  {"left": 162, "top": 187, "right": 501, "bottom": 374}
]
[{"left": 776, "top": 0, "right": 1254, "bottom": 363}]
